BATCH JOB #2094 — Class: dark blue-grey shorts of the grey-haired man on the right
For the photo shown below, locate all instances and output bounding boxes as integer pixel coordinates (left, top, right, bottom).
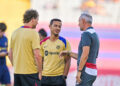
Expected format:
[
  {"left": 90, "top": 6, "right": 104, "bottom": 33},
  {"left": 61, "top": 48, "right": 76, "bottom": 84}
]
[{"left": 76, "top": 72, "right": 96, "bottom": 86}]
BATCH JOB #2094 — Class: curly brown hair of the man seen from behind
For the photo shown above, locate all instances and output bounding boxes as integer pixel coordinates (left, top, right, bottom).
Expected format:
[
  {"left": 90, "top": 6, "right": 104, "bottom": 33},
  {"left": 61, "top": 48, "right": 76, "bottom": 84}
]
[{"left": 23, "top": 9, "right": 39, "bottom": 23}]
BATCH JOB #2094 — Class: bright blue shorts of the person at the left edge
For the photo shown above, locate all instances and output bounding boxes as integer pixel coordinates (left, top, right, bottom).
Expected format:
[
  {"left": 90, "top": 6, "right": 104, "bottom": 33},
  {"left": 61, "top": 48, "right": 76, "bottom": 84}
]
[{"left": 0, "top": 65, "right": 10, "bottom": 84}]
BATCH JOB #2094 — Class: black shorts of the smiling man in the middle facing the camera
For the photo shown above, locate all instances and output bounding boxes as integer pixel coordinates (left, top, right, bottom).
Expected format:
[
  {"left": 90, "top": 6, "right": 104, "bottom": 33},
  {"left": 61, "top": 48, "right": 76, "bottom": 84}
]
[{"left": 41, "top": 75, "right": 66, "bottom": 86}]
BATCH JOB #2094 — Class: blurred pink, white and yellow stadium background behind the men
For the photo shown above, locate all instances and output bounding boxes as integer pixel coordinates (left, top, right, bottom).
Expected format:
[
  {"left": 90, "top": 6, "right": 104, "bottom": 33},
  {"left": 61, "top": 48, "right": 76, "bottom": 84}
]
[{"left": 0, "top": 0, "right": 120, "bottom": 86}]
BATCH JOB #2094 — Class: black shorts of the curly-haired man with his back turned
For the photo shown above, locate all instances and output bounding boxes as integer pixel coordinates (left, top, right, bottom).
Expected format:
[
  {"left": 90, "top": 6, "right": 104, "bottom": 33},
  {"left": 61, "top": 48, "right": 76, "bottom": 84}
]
[{"left": 14, "top": 73, "right": 41, "bottom": 86}]
